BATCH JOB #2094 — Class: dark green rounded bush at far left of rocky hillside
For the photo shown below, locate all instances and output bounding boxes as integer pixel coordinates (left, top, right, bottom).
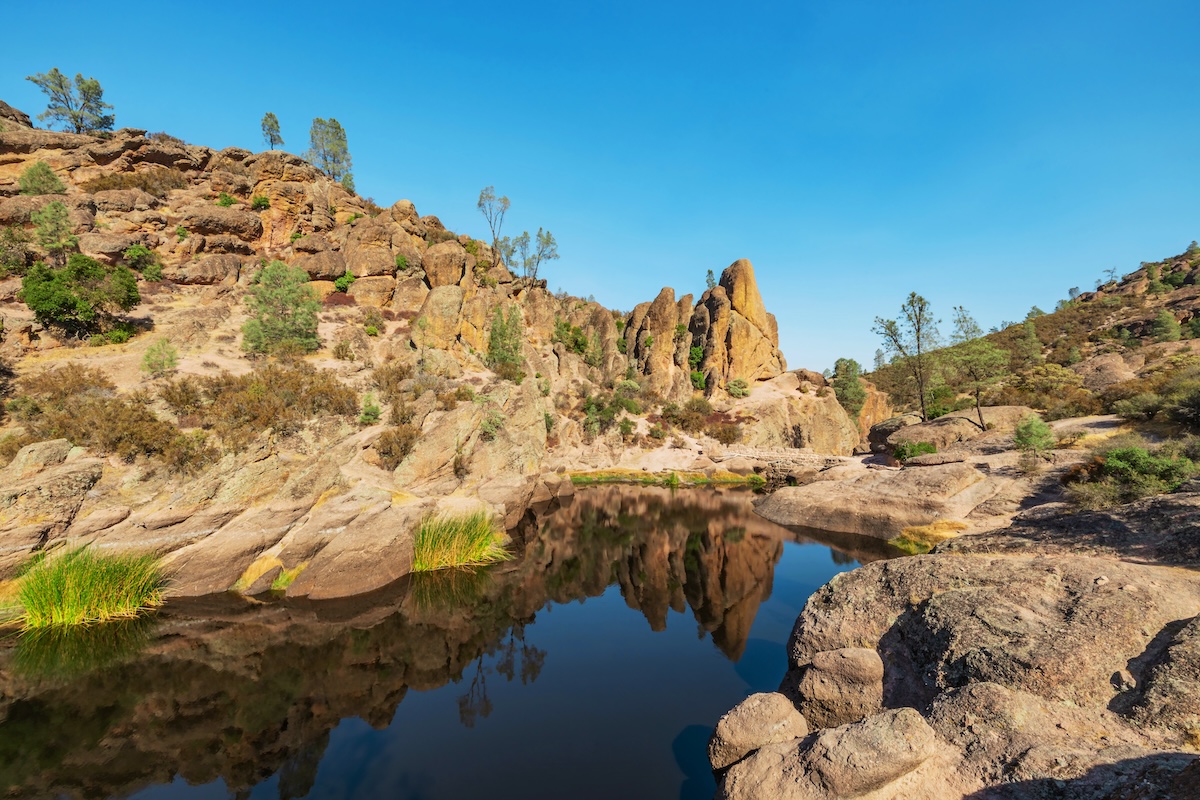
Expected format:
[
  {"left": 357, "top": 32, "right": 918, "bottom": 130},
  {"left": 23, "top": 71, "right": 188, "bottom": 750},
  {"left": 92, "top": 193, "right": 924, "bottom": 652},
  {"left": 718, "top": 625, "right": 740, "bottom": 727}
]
[{"left": 20, "top": 253, "right": 142, "bottom": 333}]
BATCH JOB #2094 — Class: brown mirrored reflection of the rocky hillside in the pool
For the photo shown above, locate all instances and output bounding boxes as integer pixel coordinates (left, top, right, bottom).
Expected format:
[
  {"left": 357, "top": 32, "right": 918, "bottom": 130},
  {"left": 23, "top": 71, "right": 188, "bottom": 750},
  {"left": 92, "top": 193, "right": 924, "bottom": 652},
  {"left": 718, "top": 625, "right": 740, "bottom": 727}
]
[{"left": 0, "top": 487, "right": 825, "bottom": 798}]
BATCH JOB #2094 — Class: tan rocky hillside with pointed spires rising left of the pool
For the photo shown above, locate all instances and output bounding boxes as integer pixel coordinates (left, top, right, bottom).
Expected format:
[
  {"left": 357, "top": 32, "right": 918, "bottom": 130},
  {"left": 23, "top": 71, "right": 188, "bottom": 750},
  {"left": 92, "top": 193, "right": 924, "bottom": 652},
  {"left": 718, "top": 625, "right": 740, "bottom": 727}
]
[{"left": 0, "top": 100, "right": 887, "bottom": 599}]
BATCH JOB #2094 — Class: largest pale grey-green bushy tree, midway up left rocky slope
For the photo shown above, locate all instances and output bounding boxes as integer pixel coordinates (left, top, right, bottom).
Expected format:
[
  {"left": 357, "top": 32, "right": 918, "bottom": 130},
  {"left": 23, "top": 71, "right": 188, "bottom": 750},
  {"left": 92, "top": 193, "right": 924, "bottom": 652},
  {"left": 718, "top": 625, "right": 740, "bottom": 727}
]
[{"left": 241, "top": 261, "right": 320, "bottom": 354}]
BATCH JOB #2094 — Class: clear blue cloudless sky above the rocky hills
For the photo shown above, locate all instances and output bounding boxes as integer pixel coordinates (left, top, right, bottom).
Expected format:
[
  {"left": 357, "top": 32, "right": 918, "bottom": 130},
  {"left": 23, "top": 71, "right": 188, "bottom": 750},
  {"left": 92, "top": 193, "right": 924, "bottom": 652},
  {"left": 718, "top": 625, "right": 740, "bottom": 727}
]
[{"left": 0, "top": 0, "right": 1200, "bottom": 369}]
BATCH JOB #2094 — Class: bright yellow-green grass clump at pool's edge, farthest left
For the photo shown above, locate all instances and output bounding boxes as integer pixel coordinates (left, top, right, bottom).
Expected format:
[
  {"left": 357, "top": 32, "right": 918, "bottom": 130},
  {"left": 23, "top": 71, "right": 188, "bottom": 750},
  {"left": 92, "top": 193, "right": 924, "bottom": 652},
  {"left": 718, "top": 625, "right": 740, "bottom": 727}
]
[{"left": 17, "top": 547, "right": 164, "bottom": 630}]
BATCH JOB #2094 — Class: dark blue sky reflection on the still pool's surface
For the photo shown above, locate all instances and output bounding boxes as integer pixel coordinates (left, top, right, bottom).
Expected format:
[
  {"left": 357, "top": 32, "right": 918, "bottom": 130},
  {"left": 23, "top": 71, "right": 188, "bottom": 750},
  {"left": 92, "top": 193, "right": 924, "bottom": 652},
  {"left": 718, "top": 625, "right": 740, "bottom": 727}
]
[{"left": 126, "top": 543, "right": 857, "bottom": 800}]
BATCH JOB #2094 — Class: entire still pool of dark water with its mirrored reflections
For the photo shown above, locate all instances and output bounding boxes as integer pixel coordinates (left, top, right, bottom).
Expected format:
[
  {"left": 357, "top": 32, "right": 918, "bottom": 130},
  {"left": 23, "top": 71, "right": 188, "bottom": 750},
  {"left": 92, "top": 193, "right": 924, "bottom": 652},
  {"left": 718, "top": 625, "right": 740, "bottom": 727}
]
[{"left": 0, "top": 488, "right": 902, "bottom": 800}]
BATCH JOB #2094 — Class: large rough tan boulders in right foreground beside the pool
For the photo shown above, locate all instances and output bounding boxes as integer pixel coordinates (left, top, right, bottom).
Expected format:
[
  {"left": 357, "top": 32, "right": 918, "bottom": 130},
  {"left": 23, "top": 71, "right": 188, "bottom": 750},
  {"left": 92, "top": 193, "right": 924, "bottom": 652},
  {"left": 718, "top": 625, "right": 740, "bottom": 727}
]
[{"left": 709, "top": 470, "right": 1200, "bottom": 800}]
